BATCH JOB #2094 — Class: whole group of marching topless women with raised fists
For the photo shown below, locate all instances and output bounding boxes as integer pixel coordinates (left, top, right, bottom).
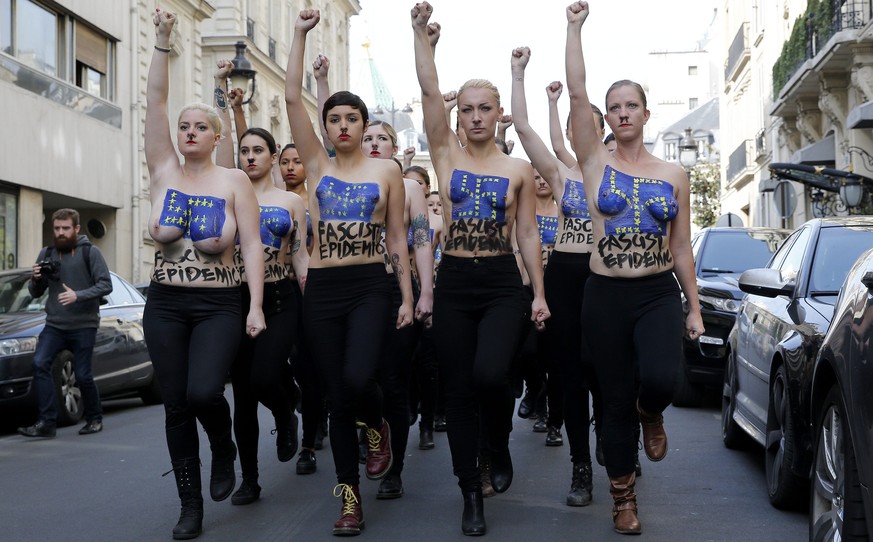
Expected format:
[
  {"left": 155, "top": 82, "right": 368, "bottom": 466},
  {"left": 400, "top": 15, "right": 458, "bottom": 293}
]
[{"left": 144, "top": 2, "right": 703, "bottom": 539}]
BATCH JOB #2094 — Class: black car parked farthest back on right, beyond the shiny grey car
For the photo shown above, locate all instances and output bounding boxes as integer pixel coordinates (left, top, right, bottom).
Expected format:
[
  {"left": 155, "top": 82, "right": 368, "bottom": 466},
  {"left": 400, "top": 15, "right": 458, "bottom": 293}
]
[{"left": 673, "top": 228, "right": 791, "bottom": 406}]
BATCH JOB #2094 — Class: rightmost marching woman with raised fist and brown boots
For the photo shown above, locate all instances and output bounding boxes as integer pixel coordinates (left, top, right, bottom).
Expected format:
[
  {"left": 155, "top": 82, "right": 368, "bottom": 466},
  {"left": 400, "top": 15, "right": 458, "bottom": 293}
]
[{"left": 566, "top": 2, "right": 704, "bottom": 534}]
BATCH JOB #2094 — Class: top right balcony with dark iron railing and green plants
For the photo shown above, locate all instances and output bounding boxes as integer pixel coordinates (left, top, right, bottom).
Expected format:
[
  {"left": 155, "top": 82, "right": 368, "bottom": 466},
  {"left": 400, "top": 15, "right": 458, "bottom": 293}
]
[{"left": 773, "top": 0, "right": 873, "bottom": 98}]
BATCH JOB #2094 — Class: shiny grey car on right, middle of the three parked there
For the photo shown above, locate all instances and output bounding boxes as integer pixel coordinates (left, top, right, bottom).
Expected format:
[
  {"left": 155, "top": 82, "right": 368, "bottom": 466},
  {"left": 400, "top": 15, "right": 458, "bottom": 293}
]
[{"left": 722, "top": 216, "right": 873, "bottom": 508}]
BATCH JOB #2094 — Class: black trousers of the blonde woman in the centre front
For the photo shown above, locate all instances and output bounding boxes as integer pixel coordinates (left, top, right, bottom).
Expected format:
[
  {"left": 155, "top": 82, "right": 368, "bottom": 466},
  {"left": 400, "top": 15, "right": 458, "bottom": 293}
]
[{"left": 433, "top": 254, "right": 527, "bottom": 492}]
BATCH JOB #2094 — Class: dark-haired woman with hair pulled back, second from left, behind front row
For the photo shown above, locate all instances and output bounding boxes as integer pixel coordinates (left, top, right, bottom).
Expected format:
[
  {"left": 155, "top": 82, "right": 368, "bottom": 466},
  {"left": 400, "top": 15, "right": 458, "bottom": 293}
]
[{"left": 215, "top": 60, "right": 309, "bottom": 505}]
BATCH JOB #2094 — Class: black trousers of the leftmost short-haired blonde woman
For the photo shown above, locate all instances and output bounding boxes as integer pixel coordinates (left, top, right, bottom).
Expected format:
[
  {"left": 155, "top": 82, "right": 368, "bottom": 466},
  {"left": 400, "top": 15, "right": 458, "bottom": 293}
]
[{"left": 143, "top": 282, "right": 243, "bottom": 461}]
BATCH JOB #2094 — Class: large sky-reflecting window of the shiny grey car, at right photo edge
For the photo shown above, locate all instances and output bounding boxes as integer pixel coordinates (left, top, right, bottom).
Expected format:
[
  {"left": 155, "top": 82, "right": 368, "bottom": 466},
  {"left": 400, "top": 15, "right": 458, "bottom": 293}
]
[{"left": 809, "top": 227, "right": 873, "bottom": 295}]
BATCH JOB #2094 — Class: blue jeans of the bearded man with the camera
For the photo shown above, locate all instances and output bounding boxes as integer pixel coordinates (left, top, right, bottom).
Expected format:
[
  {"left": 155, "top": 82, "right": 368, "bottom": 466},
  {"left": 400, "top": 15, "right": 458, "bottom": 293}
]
[{"left": 33, "top": 326, "right": 103, "bottom": 425}]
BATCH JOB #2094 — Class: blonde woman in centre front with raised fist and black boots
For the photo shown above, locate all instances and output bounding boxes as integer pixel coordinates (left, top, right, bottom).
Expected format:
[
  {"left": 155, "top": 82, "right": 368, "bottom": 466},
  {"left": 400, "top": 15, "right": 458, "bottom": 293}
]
[{"left": 411, "top": 2, "right": 549, "bottom": 535}]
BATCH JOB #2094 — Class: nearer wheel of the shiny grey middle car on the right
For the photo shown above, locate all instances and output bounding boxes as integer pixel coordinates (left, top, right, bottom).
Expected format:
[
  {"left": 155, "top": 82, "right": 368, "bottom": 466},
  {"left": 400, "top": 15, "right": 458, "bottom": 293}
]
[{"left": 764, "top": 366, "right": 806, "bottom": 510}]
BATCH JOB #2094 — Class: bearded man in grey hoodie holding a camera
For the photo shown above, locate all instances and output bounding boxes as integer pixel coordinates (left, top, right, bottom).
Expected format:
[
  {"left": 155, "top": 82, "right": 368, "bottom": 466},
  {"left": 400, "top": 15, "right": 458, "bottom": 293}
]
[{"left": 18, "top": 209, "right": 112, "bottom": 438}]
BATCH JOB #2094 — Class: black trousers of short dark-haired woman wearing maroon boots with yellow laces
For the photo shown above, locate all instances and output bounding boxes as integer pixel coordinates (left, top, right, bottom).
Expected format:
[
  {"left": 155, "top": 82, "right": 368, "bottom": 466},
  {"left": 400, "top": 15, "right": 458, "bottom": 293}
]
[{"left": 303, "top": 264, "right": 392, "bottom": 486}]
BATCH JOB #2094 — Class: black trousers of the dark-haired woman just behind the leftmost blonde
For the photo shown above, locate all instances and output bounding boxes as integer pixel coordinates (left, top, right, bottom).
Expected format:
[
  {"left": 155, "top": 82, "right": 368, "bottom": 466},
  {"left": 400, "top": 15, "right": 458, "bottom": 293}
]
[{"left": 230, "top": 278, "right": 299, "bottom": 477}]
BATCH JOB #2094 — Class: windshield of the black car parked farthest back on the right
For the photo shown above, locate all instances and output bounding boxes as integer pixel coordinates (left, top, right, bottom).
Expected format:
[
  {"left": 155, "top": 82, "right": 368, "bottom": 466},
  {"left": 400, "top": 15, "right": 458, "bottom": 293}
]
[{"left": 698, "top": 231, "right": 785, "bottom": 275}]
